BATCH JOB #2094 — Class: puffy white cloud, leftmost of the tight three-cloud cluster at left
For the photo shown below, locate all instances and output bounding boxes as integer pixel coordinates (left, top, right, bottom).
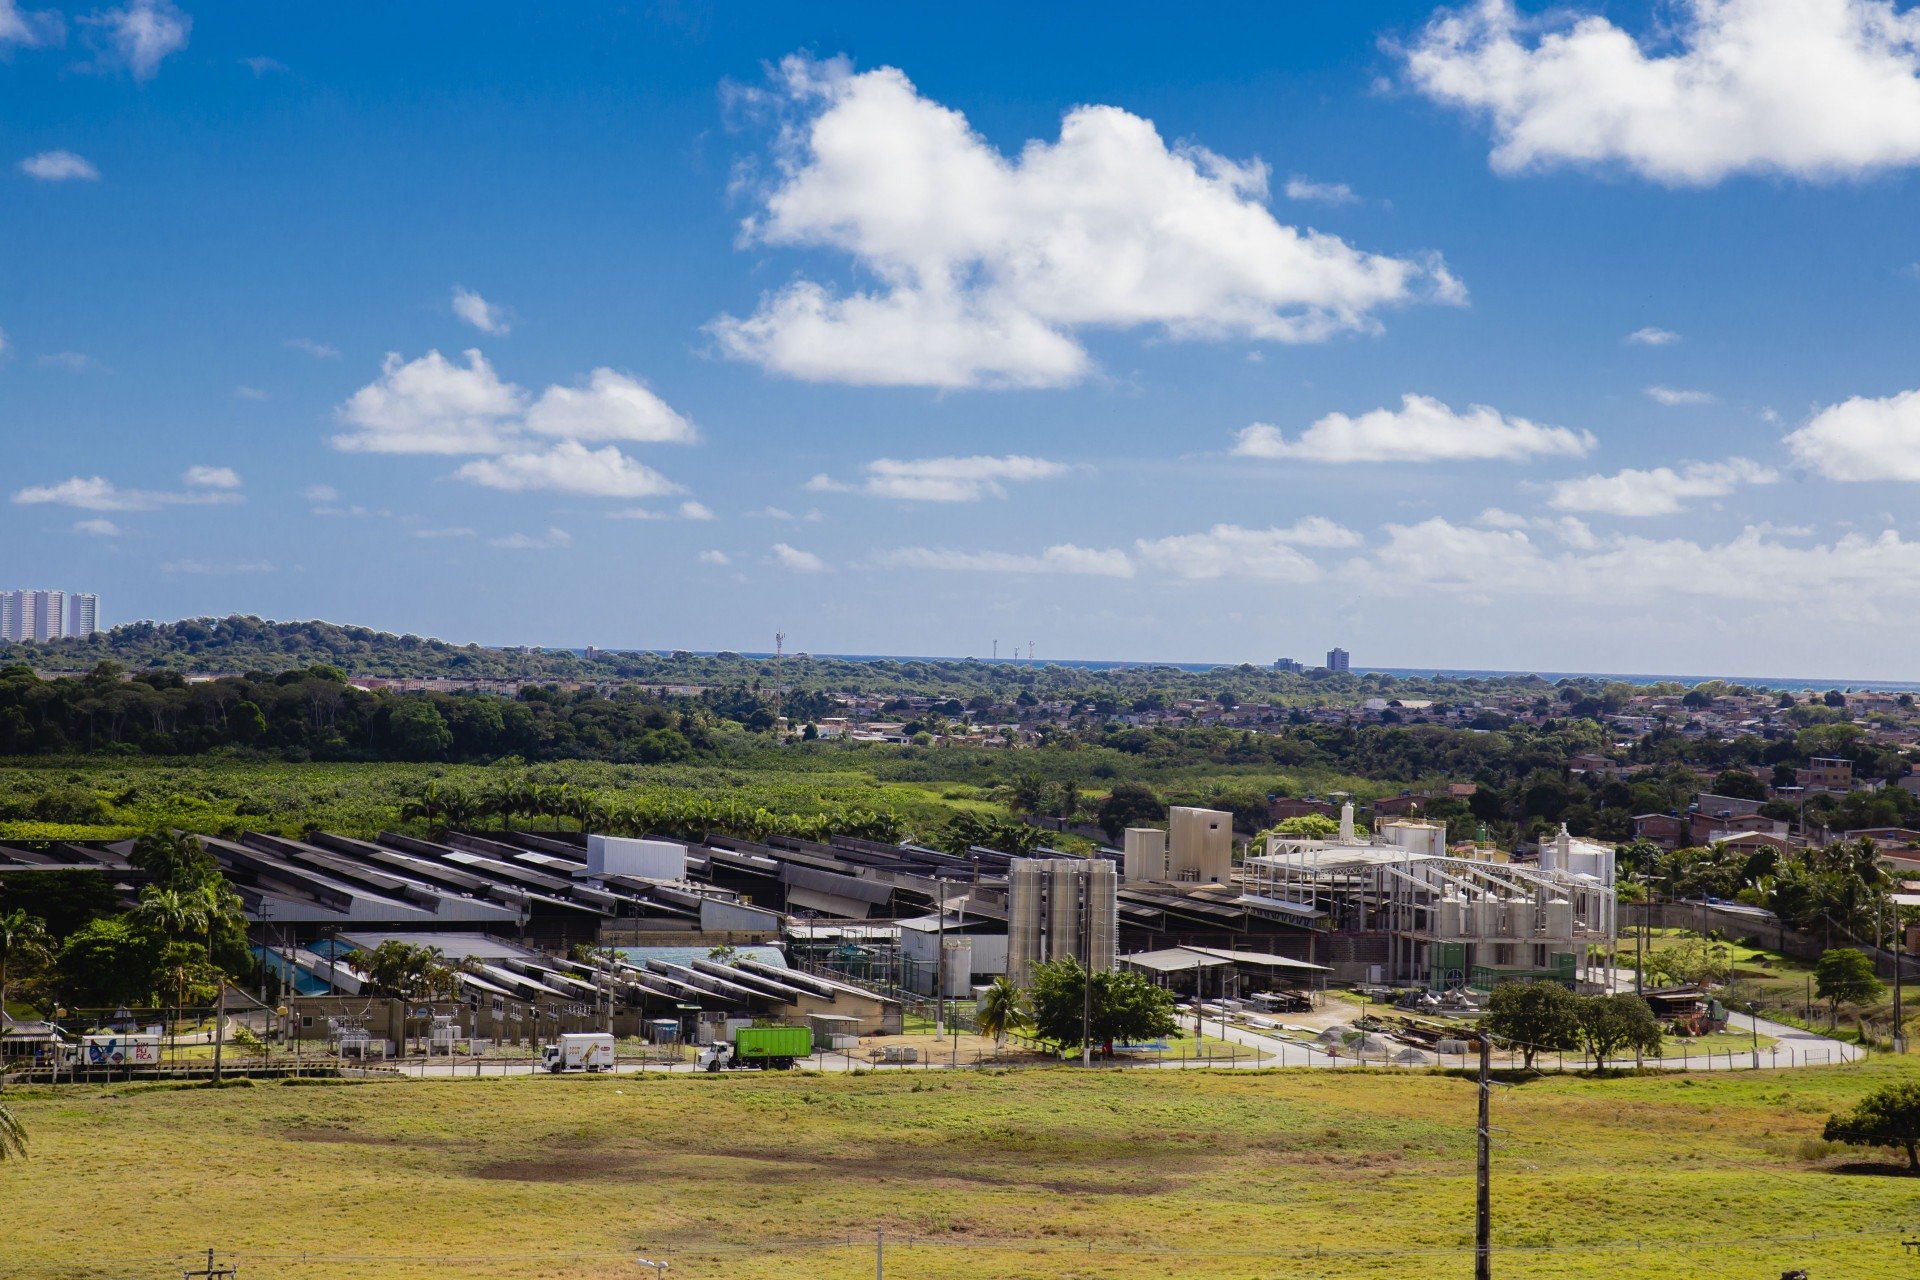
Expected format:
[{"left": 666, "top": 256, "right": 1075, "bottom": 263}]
[{"left": 334, "top": 351, "right": 526, "bottom": 453}]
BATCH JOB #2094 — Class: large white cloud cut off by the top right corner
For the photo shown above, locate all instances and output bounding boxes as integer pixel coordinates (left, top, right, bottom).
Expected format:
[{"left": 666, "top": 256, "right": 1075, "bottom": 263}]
[{"left": 1405, "top": 0, "right": 1920, "bottom": 186}]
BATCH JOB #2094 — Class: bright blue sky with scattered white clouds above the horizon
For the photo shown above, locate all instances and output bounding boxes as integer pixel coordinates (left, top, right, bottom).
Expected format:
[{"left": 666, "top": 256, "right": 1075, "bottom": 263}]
[{"left": 0, "top": 0, "right": 1920, "bottom": 677}]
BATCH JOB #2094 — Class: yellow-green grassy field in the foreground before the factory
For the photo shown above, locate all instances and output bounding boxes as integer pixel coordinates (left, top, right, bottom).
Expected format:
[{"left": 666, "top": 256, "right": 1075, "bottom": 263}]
[{"left": 0, "top": 1065, "right": 1916, "bottom": 1280}]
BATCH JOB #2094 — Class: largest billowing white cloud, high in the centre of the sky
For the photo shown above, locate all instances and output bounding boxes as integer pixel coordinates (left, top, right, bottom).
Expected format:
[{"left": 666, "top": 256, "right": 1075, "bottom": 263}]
[{"left": 710, "top": 58, "right": 1463, "bottom": 388}]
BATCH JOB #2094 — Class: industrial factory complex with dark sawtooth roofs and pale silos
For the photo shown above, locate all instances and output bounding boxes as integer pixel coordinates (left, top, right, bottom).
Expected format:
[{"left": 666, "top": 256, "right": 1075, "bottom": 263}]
[{"left": 0, "top": 808, "right": 1615, "bottom": 1044}]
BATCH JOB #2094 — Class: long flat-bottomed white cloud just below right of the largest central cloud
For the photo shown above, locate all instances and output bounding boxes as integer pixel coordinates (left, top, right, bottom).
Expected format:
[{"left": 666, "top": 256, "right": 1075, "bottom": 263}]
[{"left": 1233, "top": 395, "right": 1594, "bottom": 462}]
